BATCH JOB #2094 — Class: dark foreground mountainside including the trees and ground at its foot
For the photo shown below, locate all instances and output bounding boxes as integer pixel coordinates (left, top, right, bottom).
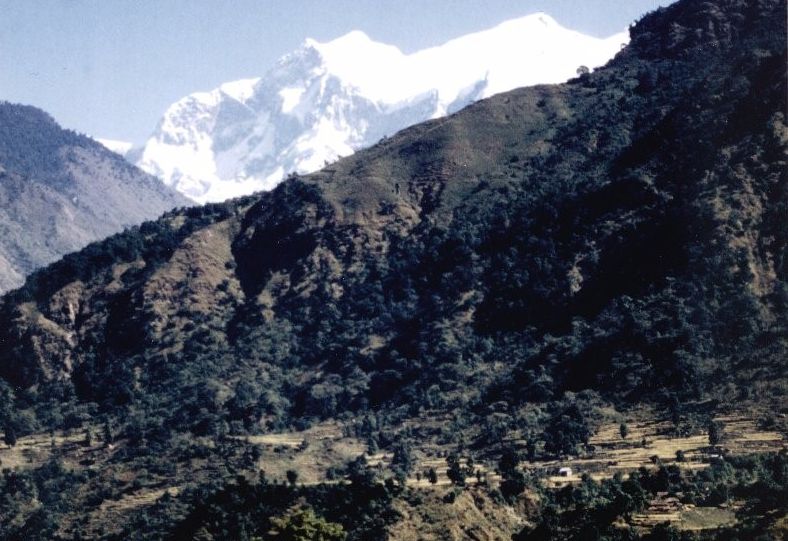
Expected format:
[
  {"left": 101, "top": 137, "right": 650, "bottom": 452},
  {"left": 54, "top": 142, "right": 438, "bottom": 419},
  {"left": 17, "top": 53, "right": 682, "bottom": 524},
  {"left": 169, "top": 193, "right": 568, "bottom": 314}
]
[{"left": 0, "top": 0, "right": 788, "bottom": 541}]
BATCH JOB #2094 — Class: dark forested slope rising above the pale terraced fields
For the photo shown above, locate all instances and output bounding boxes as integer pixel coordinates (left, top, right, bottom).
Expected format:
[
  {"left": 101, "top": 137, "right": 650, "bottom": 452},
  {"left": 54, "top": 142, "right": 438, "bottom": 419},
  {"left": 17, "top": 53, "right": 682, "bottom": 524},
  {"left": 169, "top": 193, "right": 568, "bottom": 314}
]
[{"left": 0, "top": 0, "right": 787, "bottom": 538}]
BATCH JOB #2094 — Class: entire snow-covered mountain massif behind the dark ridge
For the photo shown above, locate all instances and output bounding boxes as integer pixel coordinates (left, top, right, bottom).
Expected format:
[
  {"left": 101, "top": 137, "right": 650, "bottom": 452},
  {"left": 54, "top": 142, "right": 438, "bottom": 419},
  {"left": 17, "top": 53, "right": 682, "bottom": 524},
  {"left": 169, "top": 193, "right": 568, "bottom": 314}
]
[{"left": 134, "top": 14, "right": 627, "bottom": 202}]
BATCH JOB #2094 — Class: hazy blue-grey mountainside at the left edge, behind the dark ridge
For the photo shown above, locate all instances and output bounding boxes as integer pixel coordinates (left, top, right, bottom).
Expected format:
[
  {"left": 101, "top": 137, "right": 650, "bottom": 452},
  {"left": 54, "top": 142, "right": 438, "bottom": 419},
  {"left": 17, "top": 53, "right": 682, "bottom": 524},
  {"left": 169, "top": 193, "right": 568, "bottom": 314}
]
[{"left": 0, "top": 102, "right": 189, "bottom": 291}]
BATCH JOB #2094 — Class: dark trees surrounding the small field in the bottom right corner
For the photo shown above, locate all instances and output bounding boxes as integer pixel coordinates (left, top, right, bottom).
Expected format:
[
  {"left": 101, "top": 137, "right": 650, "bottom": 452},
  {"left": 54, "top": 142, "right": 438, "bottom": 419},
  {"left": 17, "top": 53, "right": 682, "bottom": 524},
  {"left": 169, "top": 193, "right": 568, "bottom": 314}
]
[{"left": 515, "top": 452, "right": 788, "bottom": 541}]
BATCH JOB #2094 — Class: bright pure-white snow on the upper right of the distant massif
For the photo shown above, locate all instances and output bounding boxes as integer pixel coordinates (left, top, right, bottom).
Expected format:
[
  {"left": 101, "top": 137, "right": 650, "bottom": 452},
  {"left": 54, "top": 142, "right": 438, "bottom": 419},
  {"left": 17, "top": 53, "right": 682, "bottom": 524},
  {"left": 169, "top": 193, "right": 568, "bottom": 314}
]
[{"left": 294, "top": 13, "right": 616, "bottom": 104}]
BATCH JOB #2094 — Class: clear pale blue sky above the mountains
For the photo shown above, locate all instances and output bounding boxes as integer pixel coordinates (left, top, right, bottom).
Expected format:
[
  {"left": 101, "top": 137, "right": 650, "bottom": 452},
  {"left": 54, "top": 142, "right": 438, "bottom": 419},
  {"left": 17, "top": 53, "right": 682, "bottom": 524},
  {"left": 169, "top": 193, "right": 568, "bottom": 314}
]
[{"left": 0, "top": 0, "right": 672, "bottom": 142}]
